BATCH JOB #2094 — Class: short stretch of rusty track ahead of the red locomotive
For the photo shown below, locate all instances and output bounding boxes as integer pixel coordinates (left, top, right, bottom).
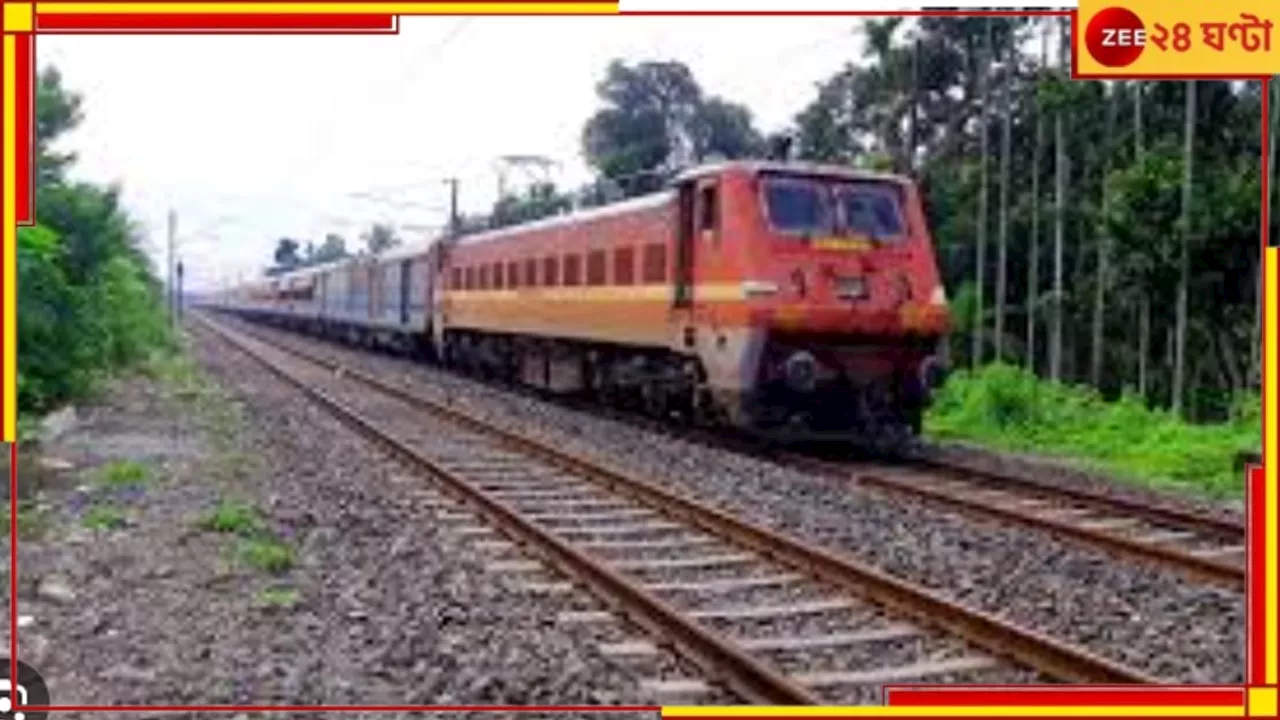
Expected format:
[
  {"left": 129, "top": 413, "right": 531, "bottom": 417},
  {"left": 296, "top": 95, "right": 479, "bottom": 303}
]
[{"left": 785, "top": 454, "right": 1247, "bottom": 589}]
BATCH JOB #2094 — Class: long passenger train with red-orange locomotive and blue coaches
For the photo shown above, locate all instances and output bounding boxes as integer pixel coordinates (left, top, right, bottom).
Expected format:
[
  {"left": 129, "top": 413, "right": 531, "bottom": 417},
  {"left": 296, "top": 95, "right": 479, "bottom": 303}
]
[{"left": 206, "top": 160, "right": 951, "bottom": 450}]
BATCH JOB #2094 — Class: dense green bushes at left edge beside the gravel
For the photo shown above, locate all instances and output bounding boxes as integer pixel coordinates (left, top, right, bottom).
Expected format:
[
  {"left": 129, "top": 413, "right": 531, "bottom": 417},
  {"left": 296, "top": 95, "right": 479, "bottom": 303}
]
[{"left": 17, "top": 70, "right": 172, "bottom": 428}]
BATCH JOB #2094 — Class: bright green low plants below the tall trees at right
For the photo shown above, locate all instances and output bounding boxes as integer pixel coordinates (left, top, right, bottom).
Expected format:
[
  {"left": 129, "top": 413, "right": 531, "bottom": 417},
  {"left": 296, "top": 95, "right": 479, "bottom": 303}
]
[{"left": 925, "top": 365, "right": 1262, "bottom": 498}]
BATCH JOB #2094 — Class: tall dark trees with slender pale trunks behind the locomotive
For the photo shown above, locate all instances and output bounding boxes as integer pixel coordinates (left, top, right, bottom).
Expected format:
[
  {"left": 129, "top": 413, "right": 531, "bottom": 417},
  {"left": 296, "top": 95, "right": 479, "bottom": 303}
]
[{"left": 795, "top": 17, "right": 1274, "bottom": 419}]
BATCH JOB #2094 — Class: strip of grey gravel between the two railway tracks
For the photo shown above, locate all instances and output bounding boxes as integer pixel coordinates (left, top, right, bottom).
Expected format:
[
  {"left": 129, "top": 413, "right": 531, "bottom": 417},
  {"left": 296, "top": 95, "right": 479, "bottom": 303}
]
[{"left": 225, "top": 316, "right": 1245, "bottom": 683}]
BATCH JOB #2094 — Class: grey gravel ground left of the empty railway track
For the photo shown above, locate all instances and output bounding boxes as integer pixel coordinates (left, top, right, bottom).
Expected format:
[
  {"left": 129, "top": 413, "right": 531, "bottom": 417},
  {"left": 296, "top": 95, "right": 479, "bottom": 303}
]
[{"left": 0, "top": 330, "right": 672, "bottom": 717}]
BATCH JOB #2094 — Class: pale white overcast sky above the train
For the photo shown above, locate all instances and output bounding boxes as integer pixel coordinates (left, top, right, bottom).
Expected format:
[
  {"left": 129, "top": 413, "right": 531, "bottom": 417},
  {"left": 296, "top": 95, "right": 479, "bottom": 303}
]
[{"left": 37, "top": 17, "right": 880, "bottom": 288}]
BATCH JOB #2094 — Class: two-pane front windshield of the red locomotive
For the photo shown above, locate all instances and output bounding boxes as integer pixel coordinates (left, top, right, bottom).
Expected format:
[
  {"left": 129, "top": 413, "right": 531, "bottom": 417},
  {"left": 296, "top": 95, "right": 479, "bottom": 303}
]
[{"left": 764, "top": 177, "right": 904, "bottom": 241}]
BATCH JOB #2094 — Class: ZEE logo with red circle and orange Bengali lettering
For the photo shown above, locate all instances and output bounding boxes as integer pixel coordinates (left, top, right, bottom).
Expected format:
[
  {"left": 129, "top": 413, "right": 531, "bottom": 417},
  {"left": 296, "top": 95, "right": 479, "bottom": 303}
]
[{"left": 1084, "top": 8, "right": 1272, "bottom": 68}]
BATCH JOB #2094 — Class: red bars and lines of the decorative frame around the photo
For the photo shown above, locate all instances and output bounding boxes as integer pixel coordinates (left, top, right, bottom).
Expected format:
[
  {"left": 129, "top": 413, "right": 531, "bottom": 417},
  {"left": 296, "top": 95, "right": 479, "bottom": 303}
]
[{"left": 0, "top": 0, "right": 1270, "bottom": 717}]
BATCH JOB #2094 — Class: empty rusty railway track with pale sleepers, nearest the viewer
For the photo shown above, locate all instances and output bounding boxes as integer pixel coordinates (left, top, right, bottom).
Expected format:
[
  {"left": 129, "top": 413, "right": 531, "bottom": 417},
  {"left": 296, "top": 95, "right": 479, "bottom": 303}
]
[{"left": 193, "top": 314, "right": 1161, "bottom": 705}]
